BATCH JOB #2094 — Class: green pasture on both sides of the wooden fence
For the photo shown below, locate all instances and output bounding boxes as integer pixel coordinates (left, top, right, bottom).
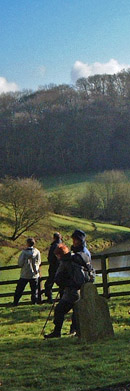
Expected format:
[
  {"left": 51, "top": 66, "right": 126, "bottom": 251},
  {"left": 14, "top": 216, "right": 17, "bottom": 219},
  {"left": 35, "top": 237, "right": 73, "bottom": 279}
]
[{"left": 0, "top": 201, "right": 130, "bottom": 391}]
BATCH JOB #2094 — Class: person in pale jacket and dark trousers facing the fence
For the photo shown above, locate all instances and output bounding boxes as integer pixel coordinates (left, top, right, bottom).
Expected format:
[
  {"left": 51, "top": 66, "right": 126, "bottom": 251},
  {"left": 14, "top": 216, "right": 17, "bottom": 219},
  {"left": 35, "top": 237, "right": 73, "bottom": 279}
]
[{"left": 13, "top": 238, "right": 41, "bottom": 306}]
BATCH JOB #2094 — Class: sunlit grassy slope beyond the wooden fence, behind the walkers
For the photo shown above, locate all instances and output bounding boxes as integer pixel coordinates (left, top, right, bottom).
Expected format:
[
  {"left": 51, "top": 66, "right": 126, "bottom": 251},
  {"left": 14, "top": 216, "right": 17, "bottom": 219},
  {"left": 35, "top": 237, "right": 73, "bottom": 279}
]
[{"left": 0, "top": 214, "right": 130, "bottom": 266}]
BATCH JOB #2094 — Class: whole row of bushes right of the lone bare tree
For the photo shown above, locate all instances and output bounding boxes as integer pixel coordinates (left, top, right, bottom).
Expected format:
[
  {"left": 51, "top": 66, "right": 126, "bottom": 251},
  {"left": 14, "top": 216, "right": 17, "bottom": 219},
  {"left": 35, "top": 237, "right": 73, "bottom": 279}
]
[{"left": 48, "top": 170, "right": 130, "bottom": 227}]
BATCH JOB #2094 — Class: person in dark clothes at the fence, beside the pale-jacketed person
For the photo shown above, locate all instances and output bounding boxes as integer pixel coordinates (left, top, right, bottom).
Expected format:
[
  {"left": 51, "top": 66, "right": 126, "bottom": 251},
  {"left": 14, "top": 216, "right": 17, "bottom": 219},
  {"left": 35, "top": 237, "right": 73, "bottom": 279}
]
[{"left": 45, "top": 232, "right": 62, "bottom": 304}]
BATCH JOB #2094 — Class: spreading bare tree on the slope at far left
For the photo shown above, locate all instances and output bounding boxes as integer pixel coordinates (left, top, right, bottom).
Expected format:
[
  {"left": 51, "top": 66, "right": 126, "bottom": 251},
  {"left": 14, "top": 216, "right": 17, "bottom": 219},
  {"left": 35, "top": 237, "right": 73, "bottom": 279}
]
[{"left": 0, "top": 178, "right": 48, "bottom": 240}]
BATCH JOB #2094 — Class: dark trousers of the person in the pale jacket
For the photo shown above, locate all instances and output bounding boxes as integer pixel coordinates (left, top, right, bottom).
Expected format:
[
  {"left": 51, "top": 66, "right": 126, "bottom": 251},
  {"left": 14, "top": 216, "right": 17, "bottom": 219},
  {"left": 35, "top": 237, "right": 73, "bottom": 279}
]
[{"left": 14, "top": 278, "right": 38, "bottom": 305}]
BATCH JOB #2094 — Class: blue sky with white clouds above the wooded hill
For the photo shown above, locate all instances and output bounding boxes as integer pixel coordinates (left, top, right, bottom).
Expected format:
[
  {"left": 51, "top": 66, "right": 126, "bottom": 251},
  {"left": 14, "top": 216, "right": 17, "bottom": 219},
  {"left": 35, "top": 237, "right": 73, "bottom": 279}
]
[{"left": 0, "top": 0, "right": 130, "bottom": 93}]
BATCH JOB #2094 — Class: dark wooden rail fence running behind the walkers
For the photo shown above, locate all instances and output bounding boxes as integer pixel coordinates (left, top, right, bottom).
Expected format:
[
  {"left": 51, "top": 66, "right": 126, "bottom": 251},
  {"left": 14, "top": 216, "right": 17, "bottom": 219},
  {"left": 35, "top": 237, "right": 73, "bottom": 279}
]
[{"left": 0, "top": 251, "right": 130, "bottom": 307}]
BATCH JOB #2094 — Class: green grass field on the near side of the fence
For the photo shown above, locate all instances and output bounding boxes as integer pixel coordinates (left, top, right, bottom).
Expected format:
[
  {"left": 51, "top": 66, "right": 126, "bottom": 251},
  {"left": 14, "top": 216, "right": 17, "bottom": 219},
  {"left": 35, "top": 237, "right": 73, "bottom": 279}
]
[{"left": 0, "top": 297, "right": 130, "bottom": 391}]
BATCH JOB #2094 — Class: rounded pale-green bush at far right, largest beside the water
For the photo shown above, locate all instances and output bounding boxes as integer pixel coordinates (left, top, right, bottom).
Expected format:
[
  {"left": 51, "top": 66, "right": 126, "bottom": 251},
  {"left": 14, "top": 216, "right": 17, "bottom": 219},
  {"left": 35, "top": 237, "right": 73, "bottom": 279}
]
[{"left": 78, "top": 170, "right": 130, "bottom": 225}]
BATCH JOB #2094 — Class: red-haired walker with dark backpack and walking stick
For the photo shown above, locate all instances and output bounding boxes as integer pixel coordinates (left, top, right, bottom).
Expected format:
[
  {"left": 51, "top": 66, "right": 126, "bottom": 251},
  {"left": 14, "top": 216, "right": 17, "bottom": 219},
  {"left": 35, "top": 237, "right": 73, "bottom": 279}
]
[{"left": 44, "top": 240, "right": 90, "bottom": 339}]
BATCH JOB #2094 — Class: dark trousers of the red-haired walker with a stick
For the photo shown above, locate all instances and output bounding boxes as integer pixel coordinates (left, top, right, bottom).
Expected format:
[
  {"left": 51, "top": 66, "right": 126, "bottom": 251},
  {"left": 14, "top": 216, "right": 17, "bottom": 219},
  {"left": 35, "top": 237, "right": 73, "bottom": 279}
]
[{"left": 54, "top": 299, "right": 76, "bottom": 332}]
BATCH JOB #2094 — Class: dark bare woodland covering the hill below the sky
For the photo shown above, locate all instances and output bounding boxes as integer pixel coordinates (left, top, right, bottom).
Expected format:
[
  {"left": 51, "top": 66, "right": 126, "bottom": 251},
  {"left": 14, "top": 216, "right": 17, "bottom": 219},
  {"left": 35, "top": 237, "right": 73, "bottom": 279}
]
[{"left": 0, "top": 69, "right": 130, "bottom": 178}]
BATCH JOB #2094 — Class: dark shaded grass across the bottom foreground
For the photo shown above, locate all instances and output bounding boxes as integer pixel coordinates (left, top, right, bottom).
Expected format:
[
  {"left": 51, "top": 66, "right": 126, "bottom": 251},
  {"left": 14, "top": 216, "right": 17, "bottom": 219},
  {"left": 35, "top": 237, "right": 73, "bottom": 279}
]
[{"left": 0, "top": 322, "right": 128, "bottom": 391}]
